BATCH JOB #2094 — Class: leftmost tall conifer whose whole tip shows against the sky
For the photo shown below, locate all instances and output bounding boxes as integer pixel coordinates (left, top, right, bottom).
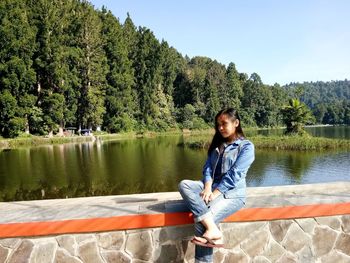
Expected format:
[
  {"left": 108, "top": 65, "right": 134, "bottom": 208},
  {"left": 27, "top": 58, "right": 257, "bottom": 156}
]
[{"left": 100, "top": 9, "right": 138, "bottom": 132}]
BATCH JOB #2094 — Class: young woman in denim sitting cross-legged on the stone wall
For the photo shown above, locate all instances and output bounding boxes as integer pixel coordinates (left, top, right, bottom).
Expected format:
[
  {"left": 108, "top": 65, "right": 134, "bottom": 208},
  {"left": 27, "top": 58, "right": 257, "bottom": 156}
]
[{"left": 179, "top": 108, "right": 254, "bottom": 263}]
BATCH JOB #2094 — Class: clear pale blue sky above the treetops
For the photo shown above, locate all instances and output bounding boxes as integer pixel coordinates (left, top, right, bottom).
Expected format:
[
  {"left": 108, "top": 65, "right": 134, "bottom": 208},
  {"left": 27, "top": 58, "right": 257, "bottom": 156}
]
[{"left": 90, "top": 0, "right": 350, "bottom": 85}]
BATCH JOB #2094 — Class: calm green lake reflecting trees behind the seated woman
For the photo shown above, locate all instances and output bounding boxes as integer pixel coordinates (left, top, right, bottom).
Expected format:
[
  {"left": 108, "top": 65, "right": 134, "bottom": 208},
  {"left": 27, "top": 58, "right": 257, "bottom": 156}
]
[{"left": 0, "top": 126, "right": 350, "bottom": 201}]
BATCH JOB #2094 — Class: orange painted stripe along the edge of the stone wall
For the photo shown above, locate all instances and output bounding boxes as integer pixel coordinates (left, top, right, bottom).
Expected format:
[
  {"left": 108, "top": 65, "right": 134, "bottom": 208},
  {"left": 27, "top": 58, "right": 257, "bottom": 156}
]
[{"left": 0, "top": 203, "right": 350, "bottom": 238}]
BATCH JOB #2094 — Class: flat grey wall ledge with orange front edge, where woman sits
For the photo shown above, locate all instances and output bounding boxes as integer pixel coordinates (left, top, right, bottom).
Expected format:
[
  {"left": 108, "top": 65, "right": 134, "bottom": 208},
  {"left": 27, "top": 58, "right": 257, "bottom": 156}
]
[{"left": 0, "top": 182, "right": 350, "bottom": 238}]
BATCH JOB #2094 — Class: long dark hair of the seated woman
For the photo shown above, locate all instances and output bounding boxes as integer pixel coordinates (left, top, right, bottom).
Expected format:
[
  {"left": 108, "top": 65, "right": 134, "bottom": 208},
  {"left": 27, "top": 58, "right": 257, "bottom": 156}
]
[{"left": 208, "top": 108, "right": 245, "bottom": 155}]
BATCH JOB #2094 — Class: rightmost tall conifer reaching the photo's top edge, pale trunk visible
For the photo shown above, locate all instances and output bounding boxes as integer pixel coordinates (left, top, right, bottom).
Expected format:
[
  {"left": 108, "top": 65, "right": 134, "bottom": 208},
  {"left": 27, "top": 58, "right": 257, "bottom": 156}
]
[{"left": 77, "top": 1, "right": 107, "bottom": 131}]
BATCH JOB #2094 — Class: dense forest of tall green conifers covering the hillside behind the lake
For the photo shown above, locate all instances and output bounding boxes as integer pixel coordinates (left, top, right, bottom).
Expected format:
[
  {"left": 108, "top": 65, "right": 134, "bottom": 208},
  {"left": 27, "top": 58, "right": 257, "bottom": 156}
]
[{"left": 0, "top": 0, "right": 350, "bottom": 137}]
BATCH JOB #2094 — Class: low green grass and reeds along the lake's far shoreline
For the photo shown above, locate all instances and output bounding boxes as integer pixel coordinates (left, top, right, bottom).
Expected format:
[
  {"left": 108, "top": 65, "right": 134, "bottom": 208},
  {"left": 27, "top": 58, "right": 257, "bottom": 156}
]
[{"left": 0, "top": 128, "right": 350, "bottom": 151}]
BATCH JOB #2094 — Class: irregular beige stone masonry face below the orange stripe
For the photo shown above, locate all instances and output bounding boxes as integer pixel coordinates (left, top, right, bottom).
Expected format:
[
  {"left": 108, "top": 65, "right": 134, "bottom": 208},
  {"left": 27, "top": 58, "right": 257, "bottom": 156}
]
[{"left": 0, "top": 215, "right": 350, "bottom": 263}]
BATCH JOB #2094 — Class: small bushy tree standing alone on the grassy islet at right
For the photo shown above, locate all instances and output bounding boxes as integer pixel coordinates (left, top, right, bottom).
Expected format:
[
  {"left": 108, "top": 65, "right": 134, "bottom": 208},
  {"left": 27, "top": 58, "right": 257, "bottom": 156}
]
[{"left": 281, "top": 99, "right": 315, "bottom": 135}]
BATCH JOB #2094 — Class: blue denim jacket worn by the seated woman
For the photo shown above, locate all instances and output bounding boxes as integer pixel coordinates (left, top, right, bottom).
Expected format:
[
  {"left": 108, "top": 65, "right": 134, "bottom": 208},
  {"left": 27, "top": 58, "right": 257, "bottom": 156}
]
[{"left": 203, "top": 138, "right": 255, "bottom": 198}]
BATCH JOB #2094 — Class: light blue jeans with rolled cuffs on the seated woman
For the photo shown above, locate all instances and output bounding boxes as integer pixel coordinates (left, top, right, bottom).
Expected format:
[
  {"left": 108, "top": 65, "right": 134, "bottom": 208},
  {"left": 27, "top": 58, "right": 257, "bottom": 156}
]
[{"left": 179, "top": 180, "right": 245, "bottom": 262}]
